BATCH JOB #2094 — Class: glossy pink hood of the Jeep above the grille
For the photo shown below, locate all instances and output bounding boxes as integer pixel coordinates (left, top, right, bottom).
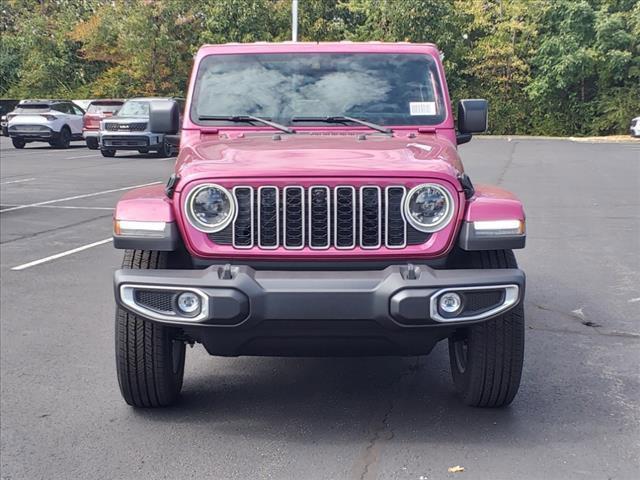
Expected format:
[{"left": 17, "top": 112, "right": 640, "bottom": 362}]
[{"left": 176, "top": 131, "right": 463, "bottom": 188}]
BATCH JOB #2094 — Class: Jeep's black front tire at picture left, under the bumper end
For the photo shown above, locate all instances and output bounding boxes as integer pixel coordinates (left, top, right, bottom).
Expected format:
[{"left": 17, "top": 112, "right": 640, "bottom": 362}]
[{"left": 115, "top": 250, "right": 185, "bottom": 408}]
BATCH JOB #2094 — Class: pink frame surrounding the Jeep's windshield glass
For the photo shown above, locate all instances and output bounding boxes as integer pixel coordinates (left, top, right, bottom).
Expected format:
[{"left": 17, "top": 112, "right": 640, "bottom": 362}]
[{"left": 188, "top": 50, "right": 453, "bottom": 131}]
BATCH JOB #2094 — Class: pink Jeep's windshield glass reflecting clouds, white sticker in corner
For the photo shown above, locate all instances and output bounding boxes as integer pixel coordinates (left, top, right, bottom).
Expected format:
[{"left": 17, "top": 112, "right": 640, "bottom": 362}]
[{"left": 192, "top": 53, "right": 446, "bottom": 125}]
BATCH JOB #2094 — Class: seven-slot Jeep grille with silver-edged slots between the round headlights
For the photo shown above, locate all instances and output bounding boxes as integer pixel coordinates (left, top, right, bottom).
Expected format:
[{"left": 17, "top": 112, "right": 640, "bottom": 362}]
[{"left": 209, "top": 185, "right": 429, "bottom": 250}]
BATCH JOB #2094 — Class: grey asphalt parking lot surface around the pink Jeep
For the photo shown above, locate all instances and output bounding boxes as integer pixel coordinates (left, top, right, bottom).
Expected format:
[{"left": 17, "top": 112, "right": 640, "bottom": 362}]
[{"left": 0, "top": 137, "right": 640, "bottom": 480}]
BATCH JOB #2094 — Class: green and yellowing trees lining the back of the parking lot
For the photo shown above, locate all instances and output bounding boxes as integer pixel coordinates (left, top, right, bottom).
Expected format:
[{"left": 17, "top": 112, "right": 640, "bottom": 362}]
[{"left": 0, "top": 0, "right": 640, "bottom": 135}]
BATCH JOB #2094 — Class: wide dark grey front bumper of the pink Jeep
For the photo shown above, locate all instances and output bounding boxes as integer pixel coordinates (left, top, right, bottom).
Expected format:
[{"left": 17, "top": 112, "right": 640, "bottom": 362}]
[{"left": 115, "top": 265, "right": 525, "bottom": 355}]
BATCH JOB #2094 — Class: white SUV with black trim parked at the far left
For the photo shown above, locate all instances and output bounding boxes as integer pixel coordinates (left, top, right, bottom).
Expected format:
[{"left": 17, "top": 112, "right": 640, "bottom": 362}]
[{"left": 7, "top": 100, "right": 84, "bottom": 148}]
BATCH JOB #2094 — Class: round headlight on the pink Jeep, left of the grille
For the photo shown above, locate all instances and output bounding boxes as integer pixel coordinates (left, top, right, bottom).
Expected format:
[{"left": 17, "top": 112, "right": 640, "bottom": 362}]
[{"left": 185, "top": 183, "right": 236, "bottom": 233}]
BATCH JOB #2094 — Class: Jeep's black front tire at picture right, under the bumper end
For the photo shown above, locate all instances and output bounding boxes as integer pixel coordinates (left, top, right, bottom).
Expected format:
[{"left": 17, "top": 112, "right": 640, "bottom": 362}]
[{"left": 449, "top": 250, "right": 524, "bottom": 407}]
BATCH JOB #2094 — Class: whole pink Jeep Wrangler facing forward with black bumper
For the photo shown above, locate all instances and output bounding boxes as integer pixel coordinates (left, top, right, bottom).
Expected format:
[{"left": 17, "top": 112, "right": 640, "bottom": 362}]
[{"left": 114, "top": 42, "right": 525, "bottom": 407}]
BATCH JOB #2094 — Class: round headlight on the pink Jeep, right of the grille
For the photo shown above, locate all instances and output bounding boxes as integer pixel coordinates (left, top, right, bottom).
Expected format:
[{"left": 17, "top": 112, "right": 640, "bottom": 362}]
[{"left": 404, "top": 183, "right": 453, "bottom": 232}]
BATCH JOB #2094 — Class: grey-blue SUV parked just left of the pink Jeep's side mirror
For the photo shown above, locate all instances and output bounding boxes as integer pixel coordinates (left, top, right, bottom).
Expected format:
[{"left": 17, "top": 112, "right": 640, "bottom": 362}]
[{"left": 100, "top": 97, "right": 184, "bottom": 157}]
